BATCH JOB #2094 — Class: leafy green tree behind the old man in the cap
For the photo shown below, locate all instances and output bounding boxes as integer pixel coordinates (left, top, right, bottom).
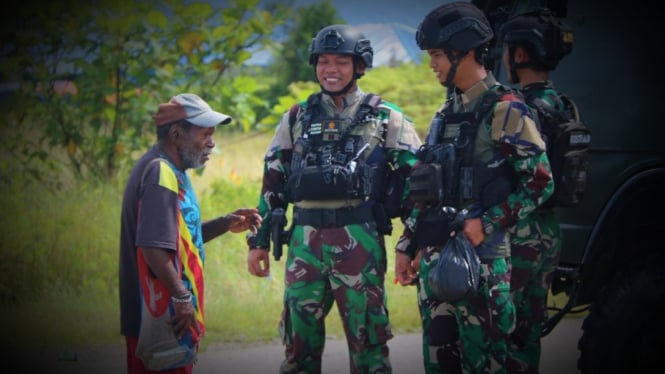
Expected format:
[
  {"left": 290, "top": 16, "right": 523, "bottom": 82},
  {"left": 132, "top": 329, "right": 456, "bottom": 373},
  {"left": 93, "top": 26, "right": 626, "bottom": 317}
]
[{"left": 0, "top": 0, "right": 290, "bottom": 183}]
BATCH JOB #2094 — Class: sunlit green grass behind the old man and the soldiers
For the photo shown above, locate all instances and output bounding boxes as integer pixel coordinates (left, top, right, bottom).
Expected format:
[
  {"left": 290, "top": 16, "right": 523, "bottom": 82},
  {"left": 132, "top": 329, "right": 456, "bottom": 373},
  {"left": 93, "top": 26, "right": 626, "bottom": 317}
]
[{"left": 0, "top": 132, "right": 565, "bottom": 356}]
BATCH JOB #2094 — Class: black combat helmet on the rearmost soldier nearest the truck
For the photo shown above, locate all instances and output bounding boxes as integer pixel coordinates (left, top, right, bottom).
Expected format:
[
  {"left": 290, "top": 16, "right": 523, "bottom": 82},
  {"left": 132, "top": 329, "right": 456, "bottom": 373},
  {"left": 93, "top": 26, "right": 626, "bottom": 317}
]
[{"left": 499, "top": 8, "right": 574, "bottom": 71}]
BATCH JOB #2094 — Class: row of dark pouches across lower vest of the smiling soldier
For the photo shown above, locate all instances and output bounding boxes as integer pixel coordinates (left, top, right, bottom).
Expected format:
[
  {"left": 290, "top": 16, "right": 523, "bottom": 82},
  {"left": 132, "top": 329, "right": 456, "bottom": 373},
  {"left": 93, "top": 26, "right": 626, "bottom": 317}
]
[{"left": 287, "top": 164, "right": 369, "bottom": 201}]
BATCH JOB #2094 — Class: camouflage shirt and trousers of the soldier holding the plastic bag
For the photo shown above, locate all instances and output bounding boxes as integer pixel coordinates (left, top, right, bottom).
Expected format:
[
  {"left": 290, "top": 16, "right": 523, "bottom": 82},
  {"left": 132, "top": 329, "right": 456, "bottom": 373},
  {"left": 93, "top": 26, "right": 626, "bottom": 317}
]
[{"left": 396, "top": 74, "right": 553, "bottom": 373}]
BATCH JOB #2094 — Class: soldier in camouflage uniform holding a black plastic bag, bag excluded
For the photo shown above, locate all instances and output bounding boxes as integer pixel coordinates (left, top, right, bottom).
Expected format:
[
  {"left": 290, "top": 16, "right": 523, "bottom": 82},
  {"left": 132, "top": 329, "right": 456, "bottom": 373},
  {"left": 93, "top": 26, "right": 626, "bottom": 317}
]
[{"left": 395, "top": 2, "right": 553, "bottom": 373}]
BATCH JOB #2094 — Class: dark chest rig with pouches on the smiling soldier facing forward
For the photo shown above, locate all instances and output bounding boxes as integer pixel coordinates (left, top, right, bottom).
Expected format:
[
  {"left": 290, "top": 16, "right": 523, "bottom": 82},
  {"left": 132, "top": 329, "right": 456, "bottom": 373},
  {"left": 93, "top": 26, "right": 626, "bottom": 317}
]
[{"left": 287, "top": 94, "right": 381, "bottom": 202}]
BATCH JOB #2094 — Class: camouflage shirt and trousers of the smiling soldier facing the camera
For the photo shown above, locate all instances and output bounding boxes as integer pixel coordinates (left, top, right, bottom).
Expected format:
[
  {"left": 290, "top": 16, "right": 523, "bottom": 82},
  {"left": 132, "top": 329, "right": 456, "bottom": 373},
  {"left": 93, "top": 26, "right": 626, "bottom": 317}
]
[{"left": 248, "top": 90, "right": 421, "bottom": 373}]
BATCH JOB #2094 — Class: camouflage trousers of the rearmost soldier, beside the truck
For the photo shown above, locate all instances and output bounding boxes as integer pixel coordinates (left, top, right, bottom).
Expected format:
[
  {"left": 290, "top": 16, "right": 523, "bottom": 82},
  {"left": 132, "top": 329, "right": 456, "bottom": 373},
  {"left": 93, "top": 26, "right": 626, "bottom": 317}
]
[{"left": 508, "top": 210, "right": 561, "bottom": 373}]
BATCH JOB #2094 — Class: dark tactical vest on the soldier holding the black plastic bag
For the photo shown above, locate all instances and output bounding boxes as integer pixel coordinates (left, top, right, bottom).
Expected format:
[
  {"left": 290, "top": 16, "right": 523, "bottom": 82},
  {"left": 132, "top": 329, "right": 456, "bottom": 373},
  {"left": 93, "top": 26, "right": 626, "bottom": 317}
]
[{"left": 409, "top": 86, "right": 517, "bottom": 248}]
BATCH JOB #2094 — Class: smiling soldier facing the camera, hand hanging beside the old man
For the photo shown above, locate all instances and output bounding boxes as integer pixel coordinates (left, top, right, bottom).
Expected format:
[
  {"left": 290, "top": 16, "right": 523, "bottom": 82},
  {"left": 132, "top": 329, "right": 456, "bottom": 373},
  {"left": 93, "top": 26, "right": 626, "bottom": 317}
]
[{"left": 248, "top": 25, "right": 421, "bottom": 373}]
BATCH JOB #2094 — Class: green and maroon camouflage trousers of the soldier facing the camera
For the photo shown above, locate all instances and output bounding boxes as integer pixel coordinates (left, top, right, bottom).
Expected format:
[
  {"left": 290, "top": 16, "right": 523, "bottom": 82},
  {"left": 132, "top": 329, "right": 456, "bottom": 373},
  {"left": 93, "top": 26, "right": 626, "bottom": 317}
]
[{"left": 279, "top": 223, "right": 393, "bottom": 374}]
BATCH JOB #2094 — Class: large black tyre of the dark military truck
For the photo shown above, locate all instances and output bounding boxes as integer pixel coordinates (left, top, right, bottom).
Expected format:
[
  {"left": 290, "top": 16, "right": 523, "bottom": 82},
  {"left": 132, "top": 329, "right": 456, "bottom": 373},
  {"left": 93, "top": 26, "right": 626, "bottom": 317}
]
[{"left": 577, "top": 255, "right": 665, "bottom": 374}]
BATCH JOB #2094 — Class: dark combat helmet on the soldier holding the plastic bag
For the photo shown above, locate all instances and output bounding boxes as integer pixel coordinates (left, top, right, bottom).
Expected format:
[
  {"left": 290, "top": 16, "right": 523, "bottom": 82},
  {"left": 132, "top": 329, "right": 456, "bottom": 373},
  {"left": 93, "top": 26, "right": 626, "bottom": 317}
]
[{"left": 416, "top": 2, "right": 494, "bottom": 52}]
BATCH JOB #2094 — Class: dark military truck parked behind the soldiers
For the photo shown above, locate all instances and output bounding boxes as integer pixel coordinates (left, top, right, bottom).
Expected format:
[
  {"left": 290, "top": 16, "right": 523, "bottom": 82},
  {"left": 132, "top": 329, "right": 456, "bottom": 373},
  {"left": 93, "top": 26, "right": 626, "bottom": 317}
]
[{"left": 472, "top": 0, "right": 665, "bottom": 373}]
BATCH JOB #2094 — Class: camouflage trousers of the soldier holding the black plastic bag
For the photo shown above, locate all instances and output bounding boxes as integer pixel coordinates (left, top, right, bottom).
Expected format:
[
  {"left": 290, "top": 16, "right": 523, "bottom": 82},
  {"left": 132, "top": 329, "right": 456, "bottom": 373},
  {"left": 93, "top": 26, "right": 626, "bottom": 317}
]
[{"left": 417, "top": 247, "right": 515, "bottom": 374}]
